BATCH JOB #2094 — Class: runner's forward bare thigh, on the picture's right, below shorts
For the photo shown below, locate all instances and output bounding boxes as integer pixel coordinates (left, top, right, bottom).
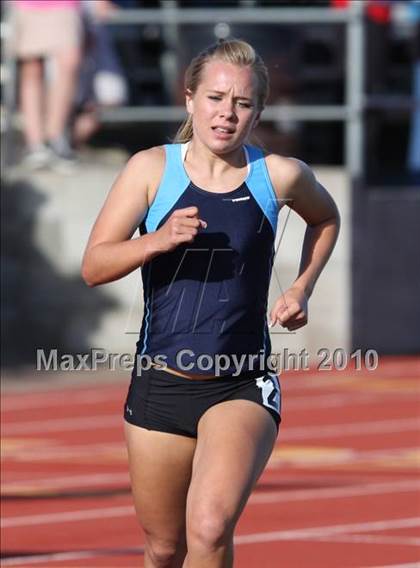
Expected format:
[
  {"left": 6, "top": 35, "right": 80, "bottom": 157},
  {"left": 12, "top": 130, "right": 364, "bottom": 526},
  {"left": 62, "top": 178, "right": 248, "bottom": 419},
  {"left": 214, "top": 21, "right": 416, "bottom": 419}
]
[{"left": 187, "top": 400, "right": 277, "bottom": 533}]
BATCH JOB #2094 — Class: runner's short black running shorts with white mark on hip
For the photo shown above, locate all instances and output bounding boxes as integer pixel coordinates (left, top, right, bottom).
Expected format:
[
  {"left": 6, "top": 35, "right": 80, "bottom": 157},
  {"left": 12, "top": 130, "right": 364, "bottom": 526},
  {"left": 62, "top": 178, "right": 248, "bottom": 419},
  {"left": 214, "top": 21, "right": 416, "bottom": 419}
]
[{"left": 124, "top": 367, "right": 281, "bottom": 438}]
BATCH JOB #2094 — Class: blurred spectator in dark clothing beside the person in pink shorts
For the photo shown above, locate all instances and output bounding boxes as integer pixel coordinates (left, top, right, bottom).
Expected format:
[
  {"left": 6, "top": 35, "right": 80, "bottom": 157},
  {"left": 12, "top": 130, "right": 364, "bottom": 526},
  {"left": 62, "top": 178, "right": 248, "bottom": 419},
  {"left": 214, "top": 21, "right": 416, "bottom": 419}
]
[{"left": 72, "top": 0, "right": 128, "bottom": 146}]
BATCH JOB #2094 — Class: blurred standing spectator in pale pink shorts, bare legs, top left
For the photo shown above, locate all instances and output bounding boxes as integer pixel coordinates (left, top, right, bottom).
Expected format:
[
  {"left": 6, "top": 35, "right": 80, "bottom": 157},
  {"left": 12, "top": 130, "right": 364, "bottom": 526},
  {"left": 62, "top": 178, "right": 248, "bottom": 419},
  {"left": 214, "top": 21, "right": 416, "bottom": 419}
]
[{"left": 12, "top": 0, "right": 81, "bottom": 169}]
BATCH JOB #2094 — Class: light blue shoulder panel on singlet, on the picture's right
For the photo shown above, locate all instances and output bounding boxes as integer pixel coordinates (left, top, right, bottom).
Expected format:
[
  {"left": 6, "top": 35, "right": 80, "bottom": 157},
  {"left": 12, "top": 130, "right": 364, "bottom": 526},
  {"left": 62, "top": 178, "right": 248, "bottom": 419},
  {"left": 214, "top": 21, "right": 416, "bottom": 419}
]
[{"left": 245, "top": 144, "right": 280, "bottom": 234}]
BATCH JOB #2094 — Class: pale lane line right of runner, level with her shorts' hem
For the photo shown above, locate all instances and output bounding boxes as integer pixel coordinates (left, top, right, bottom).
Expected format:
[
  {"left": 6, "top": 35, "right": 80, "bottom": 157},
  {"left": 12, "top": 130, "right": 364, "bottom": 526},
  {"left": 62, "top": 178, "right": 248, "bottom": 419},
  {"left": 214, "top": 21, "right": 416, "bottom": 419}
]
[{"left": 279, "top": 418, "right": 420, "bottom": 441}]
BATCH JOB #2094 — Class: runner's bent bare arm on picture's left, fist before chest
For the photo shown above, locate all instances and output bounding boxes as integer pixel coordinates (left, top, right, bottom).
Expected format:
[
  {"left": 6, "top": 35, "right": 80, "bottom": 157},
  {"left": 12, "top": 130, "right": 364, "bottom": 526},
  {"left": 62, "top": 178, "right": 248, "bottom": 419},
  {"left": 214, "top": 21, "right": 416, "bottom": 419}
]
[{"left": 82, "top": 148, "right": 205, "bottom": 286}]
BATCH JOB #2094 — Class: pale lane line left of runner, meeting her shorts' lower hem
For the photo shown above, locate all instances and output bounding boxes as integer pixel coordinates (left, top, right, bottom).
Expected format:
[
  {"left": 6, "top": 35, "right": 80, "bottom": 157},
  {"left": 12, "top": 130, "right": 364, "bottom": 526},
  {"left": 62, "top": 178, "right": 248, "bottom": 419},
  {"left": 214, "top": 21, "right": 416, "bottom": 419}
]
[{"left": 3, "top": 410, "right": 123, "bottom": 437}]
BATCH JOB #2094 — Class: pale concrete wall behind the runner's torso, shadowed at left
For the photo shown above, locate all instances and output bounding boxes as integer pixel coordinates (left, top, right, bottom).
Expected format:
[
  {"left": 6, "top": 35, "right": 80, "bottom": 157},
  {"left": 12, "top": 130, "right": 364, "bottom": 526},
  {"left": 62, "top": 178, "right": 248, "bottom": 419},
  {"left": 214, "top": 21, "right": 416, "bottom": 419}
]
[{"left": 3, "top": 155, "right": 350, "bottom": 363}]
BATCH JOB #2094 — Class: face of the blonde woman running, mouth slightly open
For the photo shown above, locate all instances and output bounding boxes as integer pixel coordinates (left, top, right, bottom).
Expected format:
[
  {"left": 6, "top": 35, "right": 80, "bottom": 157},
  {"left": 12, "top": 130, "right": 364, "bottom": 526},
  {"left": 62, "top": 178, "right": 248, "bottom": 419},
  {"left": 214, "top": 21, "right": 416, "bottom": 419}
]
[{"left": 186, "top": 60, "right": 260, "bottom": 154}]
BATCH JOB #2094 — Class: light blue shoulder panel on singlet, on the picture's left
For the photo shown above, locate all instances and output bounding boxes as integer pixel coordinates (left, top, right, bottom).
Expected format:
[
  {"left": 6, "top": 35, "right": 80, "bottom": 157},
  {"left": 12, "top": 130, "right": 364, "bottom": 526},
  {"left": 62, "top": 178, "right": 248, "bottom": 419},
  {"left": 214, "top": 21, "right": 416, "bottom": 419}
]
[{"left": 145, "top": 144, "right": 190, "bottom": 233}]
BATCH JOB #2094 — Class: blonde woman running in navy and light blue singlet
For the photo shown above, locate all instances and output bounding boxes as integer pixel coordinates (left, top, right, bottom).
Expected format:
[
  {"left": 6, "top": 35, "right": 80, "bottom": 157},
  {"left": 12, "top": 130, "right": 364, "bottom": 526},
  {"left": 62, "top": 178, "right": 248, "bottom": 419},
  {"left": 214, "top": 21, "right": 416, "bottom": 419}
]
[{"left": 82, "top": 40, "right": 339, "bottom": 568}]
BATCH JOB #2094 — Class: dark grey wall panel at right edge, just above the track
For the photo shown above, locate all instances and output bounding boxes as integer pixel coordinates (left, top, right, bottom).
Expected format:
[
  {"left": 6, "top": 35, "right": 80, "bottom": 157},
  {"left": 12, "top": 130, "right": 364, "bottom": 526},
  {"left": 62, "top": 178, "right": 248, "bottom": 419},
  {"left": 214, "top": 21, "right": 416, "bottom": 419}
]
[{"left": 352, "top": 185, "right": 420, "bottom": 355}]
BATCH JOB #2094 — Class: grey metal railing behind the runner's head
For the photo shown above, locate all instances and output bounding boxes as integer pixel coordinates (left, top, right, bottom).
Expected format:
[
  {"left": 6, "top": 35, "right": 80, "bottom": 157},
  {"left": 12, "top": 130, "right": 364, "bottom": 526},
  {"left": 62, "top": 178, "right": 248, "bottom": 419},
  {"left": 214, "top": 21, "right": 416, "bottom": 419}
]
[{"left": 101, "top": 0, "right": 364, "bottom": 177}]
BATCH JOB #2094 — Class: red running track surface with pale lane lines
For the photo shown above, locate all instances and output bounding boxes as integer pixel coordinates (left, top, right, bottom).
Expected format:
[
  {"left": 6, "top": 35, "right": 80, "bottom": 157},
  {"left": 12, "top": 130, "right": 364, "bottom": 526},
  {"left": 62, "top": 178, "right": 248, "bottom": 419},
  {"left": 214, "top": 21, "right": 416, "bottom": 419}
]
[{"left": 2, "top": 359, "right": 420, "bottom": 568}]
